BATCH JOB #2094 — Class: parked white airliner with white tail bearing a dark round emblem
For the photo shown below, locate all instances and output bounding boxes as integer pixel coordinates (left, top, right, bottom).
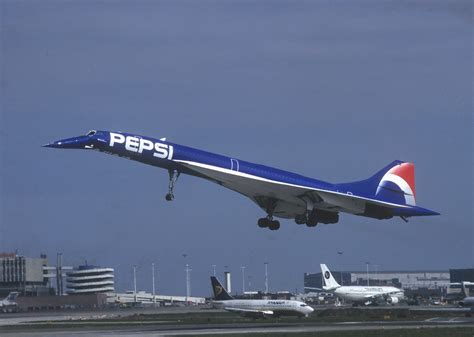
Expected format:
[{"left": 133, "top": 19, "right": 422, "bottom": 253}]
[{"left": 321, "top": 264, "right": 405, "bottom": 305}]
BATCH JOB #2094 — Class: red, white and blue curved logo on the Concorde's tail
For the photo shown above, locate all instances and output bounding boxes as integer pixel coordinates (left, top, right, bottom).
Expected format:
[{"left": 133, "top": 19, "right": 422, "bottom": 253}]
[{"left": 375, "top": 163, "right": 416, "bottom": 206}]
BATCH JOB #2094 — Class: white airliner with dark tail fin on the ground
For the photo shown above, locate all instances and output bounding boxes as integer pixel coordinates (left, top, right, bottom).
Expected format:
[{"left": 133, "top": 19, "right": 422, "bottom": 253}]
[{"left": 211, "top": 276, "right": 314, "bottom": 318}]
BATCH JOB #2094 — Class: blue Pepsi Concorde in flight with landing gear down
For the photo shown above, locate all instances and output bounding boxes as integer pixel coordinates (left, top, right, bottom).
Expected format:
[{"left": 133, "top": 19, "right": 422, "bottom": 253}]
[{"left": 44, "top": 130, "right": 439, "bottom": 230}]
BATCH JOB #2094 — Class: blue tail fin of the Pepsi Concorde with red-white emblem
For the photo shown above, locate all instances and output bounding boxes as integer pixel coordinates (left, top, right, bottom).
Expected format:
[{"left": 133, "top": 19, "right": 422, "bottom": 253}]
[{"left": 339, "top": 160, "right": 416, "bottom": 206}]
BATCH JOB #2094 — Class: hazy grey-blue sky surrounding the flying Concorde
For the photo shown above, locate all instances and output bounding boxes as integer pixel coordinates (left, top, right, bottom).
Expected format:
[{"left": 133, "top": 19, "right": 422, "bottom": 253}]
[{"left": 0, "top": 0, "right": 474, "bottom": 296}]
